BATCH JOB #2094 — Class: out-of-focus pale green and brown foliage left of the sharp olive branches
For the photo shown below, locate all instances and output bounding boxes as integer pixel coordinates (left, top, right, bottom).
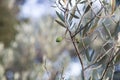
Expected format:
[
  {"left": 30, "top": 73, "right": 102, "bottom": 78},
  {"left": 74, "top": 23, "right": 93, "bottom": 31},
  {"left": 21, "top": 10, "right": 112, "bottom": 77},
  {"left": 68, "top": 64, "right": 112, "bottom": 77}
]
[{"left": 0, "top": 0, "right": 74, "bottom": 80}]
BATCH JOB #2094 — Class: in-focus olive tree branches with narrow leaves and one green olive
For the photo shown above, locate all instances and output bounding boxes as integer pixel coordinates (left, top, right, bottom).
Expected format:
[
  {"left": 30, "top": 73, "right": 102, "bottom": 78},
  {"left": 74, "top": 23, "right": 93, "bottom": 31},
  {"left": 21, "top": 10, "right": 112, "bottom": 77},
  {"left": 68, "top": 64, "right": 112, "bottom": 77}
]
[{"left": 54, "top": 0, "right": 120, "bottom": 80}]
